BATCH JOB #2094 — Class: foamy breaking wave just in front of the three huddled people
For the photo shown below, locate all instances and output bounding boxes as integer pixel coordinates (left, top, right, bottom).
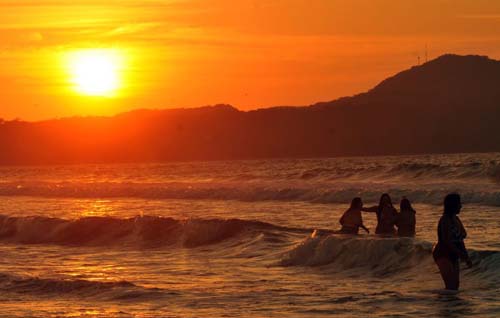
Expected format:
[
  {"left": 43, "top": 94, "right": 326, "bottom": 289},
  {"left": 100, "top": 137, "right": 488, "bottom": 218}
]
[{"left": 280, "top": 235, "right": 500, "bottom": 281}]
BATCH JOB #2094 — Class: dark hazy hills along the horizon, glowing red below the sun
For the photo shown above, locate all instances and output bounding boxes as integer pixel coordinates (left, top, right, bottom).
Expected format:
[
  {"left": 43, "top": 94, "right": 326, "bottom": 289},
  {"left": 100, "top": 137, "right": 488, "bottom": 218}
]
[{"left": 0, "top": 55, "right": 500, "bottom": 164}]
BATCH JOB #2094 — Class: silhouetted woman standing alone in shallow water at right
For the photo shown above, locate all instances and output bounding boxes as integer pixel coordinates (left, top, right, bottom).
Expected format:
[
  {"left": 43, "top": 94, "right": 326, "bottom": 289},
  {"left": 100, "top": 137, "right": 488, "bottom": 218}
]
[{"left": 432, "top": 193, "right": 472, "bottom": 290}]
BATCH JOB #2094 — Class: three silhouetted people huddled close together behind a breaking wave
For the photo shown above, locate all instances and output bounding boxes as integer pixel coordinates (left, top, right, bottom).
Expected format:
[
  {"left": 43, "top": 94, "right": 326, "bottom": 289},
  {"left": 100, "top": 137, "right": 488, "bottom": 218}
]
[{"left": 339, "top": 193, "right": 416, "bottom": 236}]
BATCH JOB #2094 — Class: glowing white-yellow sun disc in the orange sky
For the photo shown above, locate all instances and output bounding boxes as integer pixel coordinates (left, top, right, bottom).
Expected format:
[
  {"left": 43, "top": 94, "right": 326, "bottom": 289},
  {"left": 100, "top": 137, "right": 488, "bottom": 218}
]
[{"left": 69, "top": 49, "right": 121, "bottom": 96}]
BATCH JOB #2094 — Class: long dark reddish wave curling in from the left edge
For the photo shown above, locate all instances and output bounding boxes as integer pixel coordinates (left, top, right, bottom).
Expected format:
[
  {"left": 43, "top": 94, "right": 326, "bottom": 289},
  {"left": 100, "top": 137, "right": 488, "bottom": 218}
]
[{"left": 0, "top": 215, "right": 300, "bottom": 248}]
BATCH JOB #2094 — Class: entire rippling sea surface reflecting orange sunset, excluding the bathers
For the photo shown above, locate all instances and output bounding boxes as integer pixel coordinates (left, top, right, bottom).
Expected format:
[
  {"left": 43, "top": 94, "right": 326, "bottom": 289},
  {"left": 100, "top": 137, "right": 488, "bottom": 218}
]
[{"left": 0, "top": 153, "right": 500, "bottom": 317}]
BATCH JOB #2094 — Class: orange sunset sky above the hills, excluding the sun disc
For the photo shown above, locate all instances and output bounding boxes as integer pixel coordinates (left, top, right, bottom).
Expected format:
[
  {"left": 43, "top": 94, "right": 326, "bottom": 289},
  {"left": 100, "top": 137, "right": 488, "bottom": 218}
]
[{"left": 0, "top": 0, "right": 500, "bottom": 120}]
